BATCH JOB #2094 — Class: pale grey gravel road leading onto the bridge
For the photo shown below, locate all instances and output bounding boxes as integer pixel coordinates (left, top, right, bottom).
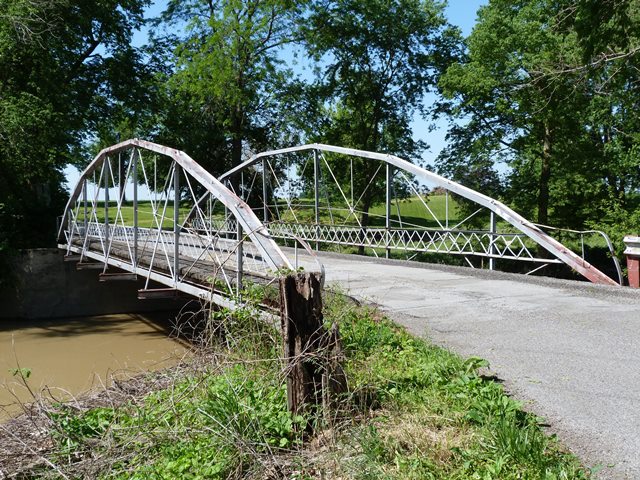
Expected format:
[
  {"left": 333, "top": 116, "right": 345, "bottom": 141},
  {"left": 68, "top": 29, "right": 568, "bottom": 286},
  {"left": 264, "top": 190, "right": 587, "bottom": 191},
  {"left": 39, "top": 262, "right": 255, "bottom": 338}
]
[{"left": 294, "top": 254, "right": 640, "bottom": 479}]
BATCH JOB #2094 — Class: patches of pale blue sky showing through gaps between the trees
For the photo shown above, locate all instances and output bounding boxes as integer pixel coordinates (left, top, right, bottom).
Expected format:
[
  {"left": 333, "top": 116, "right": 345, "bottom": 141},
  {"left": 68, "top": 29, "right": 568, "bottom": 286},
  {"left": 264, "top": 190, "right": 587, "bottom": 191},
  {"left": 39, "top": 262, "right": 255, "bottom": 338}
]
[{"left": 64, "top": 0, "right": 488, "bottom": 195}]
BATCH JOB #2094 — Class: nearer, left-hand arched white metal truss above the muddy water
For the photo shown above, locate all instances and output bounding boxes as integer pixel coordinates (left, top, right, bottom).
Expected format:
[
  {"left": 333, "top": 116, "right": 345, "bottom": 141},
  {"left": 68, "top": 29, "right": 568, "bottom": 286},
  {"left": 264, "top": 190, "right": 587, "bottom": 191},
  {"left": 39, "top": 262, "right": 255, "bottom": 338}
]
[{"left": 58, "top": 139, "right": 293, "bottom": 304}]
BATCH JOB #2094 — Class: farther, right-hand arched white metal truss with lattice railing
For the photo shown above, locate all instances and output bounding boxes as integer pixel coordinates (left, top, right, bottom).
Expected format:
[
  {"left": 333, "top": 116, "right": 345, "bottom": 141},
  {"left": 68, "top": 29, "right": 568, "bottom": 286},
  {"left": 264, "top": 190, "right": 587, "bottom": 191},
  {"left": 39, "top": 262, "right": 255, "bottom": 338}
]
[{"left": 219, "top": 144, "right": 617, "bottom": 285}]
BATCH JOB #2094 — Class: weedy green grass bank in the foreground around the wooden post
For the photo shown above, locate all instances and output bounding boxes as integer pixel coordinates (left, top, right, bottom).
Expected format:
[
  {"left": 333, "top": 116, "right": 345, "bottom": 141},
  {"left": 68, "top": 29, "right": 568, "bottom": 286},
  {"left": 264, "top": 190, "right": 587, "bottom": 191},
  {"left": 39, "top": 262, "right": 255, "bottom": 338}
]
[{"left": 5, "top": 286, "right": 590, "bottom": 480}]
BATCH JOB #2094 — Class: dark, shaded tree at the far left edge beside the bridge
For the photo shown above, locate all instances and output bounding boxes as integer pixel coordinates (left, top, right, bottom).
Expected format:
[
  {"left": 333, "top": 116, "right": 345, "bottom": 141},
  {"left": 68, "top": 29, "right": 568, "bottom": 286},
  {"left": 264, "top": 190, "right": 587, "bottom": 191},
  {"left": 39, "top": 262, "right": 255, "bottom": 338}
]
[{"left": 0, "top": 0, "right": 145, "bottom": 284}]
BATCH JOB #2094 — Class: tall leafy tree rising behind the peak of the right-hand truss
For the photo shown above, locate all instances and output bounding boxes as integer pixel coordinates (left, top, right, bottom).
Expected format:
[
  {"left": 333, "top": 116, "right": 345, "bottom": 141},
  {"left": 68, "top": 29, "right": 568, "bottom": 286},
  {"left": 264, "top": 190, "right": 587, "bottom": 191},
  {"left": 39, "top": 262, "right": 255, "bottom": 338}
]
[{"left": 305, "top": 0, "right": 458, "bottom": 234}]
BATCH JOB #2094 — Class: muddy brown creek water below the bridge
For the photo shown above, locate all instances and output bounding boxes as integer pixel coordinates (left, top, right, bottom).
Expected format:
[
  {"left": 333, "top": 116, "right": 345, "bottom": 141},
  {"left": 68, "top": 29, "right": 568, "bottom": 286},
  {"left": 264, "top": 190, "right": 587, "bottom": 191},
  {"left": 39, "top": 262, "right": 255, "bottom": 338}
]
[{"left": 0, "top": 312, "right": 189, "bottom": 420}]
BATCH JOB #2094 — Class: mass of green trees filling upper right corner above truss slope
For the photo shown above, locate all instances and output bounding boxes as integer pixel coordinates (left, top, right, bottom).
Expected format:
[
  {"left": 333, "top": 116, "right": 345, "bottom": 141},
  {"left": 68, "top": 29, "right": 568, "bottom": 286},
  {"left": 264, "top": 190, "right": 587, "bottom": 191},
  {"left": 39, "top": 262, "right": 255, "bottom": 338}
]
[{"left": 438, "top": 0, "right": 638, "bottom": 240}]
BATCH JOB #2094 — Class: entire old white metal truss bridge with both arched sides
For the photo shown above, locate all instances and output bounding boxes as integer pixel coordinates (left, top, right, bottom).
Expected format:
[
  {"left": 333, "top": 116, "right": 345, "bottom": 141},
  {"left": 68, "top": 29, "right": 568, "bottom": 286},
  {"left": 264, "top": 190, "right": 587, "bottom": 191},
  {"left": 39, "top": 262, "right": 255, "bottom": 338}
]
[{"left": 58, "top": 139, "right": 621, "bottom": 308}]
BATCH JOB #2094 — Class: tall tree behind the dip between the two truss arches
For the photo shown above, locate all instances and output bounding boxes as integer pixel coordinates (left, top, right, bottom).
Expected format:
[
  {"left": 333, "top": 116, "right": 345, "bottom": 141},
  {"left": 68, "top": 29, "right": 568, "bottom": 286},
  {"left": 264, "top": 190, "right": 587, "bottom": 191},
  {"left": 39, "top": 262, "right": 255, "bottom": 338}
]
[{"left": 152, "top": 0, "right": 304, "bottom": 184}]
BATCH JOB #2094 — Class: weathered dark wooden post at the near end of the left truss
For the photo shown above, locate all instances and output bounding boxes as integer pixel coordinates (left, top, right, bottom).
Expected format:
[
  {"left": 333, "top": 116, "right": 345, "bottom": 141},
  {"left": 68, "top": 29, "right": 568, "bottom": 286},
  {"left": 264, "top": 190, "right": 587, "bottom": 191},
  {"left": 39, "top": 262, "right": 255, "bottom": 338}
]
[{"left": 280, "top": 272, "right": 344, "bottom": 426}]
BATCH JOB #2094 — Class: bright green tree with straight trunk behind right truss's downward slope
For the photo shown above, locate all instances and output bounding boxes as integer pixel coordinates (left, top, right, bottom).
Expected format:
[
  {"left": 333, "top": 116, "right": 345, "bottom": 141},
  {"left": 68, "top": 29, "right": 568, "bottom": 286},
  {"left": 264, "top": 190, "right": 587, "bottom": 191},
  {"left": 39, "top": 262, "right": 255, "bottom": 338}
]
[{"left": 438, "top": 0, "right": 593, "bottom": 224}]
